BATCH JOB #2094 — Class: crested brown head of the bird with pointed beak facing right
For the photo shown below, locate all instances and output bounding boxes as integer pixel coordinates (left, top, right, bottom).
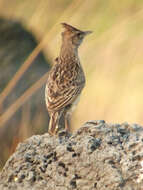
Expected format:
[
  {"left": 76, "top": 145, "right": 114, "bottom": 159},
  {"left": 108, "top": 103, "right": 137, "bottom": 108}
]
[{"left": 62, "top": 23, "right": 92, "bottom": 47}]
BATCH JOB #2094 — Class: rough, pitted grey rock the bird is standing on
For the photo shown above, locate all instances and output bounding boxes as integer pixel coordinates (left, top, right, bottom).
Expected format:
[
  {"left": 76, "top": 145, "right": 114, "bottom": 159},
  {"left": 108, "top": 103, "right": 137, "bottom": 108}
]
[{"left": 0, "top": 120, "right": 143, "bottom": 190}]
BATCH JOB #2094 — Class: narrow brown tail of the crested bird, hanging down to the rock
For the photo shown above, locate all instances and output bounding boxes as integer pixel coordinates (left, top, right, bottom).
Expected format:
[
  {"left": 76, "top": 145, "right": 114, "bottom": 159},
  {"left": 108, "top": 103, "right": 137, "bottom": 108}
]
[{"left": 48, "top": 112, "right": 59, "bottom": 134}]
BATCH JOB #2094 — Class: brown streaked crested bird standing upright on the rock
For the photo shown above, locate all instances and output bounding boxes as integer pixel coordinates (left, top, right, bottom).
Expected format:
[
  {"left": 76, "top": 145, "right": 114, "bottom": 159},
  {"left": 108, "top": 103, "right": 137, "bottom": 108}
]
[{"left": 45, "top": 23, "right": 92, "bottom": 135}]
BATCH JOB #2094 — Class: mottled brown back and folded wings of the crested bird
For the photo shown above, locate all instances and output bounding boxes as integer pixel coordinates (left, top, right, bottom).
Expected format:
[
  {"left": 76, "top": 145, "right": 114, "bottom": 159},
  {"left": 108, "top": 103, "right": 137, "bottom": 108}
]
[{"left": 45, "top": 61, "right": 84, "bottom": 111}]
